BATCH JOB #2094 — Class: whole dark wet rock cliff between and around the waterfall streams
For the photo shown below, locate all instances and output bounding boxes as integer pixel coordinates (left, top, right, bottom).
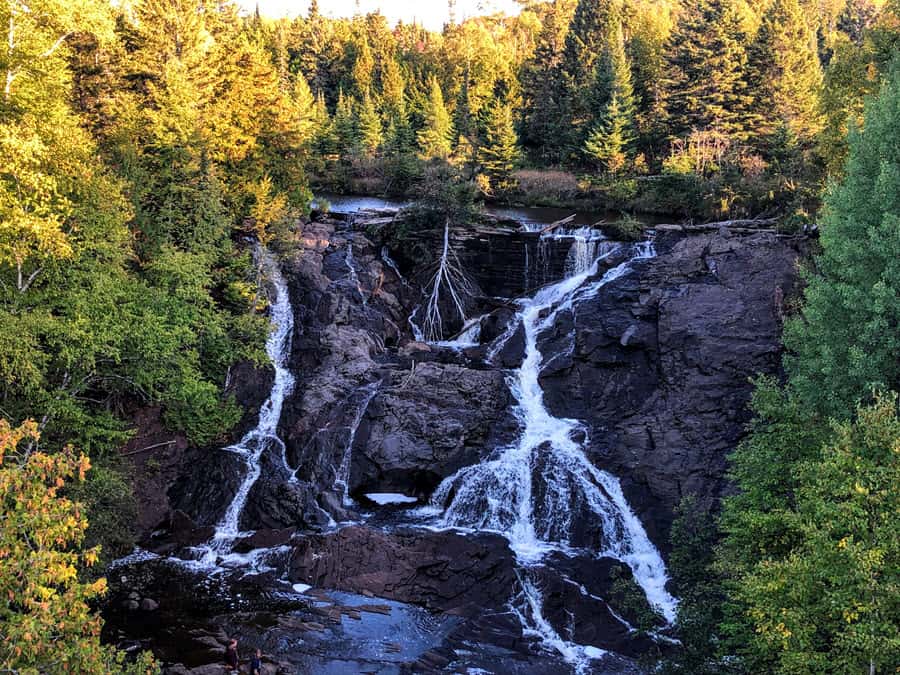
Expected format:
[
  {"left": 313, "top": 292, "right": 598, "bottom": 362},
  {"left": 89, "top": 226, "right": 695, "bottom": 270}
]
[{"left": 118, "top": 219, "right": 805, "bottom": 672}]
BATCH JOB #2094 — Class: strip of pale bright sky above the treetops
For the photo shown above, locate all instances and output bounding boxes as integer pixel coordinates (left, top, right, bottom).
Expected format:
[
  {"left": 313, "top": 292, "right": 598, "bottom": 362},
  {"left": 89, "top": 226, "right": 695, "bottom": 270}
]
[{"left": 238, "top": 0, "right": 518, "bottom": 30}]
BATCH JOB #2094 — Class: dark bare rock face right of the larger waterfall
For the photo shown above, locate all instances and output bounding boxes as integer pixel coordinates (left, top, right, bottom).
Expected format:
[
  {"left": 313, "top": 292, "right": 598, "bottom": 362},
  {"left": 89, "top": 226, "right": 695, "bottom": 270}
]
[{"left": 541, "top": 232, "right": 800, "bottom": 547}]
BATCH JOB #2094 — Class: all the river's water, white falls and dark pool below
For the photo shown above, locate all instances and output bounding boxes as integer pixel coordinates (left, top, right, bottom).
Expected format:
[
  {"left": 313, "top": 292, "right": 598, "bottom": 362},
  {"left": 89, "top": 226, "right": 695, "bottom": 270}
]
[{"left": 105, "top": 203, "right": 677, "bottom": 675}]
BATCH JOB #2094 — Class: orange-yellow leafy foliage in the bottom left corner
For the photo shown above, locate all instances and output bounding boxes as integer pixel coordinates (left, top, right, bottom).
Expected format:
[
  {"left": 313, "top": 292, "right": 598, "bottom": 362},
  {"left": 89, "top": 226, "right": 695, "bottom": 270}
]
[{"left": 0, "top": 419, "right": 158, "bottom": 675}]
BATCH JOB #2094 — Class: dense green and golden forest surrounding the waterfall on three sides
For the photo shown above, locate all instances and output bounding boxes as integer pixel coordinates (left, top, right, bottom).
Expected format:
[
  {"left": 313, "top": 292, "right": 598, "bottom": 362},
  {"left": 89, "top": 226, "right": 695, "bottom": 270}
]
[{"left": 0, "top": 0, "right": 900, "bottom": 673}]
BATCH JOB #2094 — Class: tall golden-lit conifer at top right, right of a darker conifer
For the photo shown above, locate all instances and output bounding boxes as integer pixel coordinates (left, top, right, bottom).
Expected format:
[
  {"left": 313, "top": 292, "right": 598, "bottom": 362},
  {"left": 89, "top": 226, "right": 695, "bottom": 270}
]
[{"left": 747, "top": 0, "right": 822, "bottom": 141}]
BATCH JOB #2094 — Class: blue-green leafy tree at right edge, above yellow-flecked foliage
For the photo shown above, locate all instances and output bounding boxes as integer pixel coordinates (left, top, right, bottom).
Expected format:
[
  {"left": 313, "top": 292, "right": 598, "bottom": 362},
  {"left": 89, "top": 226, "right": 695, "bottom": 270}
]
[{"left": 785, "top": 63, "right": 900, "bottom": 416}]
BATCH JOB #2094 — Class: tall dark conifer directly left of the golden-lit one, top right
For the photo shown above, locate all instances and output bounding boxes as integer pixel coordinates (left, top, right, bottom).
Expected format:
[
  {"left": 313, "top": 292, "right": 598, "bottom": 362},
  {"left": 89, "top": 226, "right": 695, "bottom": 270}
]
[{"left": 666, "top": 0, "right": 749, "bottom": 138}]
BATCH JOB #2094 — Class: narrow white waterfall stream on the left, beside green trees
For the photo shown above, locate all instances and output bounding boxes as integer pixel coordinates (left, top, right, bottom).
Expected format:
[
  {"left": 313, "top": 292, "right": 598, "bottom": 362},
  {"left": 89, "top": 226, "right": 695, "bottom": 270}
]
[{"left": 211, "top": 249, "right": 294, "bottom": 553}]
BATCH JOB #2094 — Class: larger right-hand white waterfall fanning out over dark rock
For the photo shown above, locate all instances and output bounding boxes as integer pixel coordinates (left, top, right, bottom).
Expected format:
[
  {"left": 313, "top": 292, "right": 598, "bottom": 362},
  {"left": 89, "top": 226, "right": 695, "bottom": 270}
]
[{"left": 432, "top": 242, "right": 677, "bottom": 658}]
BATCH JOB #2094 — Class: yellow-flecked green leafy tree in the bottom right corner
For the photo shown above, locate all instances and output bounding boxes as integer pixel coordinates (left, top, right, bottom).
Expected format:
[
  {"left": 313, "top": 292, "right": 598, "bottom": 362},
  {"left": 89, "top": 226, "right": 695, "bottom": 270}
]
[{"left": 733, "top": 396, "right": 900, "bottom": 673}]
